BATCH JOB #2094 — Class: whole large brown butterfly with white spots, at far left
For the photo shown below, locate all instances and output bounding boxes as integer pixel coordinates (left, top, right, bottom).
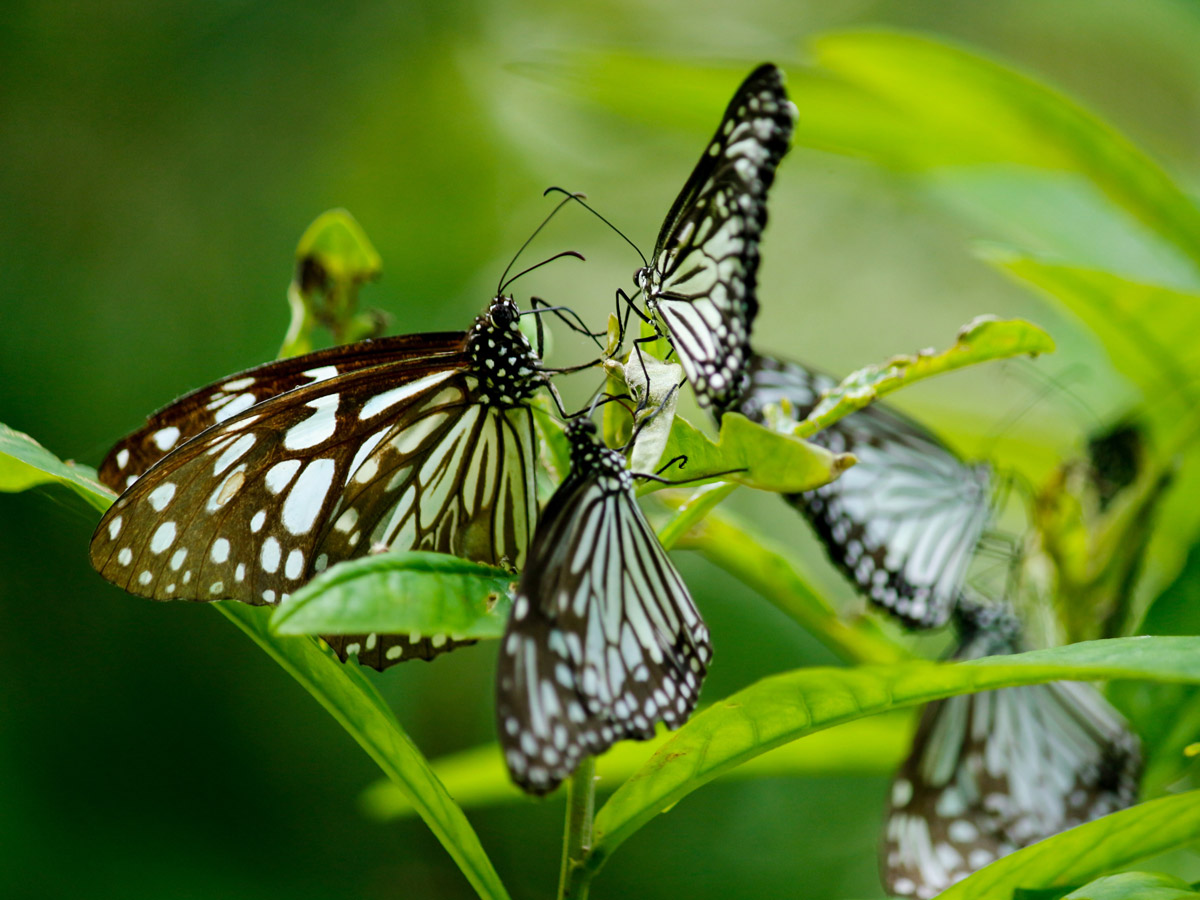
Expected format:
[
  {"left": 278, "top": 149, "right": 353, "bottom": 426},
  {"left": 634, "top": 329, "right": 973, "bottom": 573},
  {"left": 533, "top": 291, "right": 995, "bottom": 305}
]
[{"left": 91, "top": 296, "right": 548, "bottom": 670}]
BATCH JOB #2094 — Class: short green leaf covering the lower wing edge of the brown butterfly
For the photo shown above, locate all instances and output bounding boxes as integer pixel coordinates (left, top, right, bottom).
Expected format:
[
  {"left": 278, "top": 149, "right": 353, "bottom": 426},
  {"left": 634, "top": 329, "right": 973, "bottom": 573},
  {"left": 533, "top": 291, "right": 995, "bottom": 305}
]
[{"left": 271, "top": 550, "right": 515, "bottom": 640}]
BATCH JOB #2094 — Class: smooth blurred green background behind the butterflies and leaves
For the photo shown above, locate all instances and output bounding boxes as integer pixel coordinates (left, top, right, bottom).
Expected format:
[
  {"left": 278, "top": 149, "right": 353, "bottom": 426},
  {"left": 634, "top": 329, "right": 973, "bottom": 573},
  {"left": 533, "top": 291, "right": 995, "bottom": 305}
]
[{"left": 0, "top": 0, "right": 1200, "bottom": 900}]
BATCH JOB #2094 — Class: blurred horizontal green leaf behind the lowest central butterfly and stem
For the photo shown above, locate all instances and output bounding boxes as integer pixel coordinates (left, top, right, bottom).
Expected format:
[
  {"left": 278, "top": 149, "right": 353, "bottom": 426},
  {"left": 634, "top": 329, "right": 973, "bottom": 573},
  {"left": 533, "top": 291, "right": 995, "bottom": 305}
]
[{"left": 361, "top": 715, "right": 912, "bottom": 820}]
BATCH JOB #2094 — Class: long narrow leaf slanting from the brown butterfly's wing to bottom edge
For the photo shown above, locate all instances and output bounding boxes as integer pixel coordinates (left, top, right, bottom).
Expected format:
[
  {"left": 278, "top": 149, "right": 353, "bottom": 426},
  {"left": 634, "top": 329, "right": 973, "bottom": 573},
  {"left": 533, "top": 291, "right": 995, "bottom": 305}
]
[{"left": 214, "top": 601, "right": 508, "bottom": 900}]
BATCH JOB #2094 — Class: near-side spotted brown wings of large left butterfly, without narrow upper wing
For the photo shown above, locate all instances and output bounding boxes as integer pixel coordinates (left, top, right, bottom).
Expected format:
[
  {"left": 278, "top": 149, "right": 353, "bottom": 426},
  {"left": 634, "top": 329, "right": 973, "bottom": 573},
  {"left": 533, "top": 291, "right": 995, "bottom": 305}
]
[{"left": 91, "top": 354, "right": 536, "bottom": 665}]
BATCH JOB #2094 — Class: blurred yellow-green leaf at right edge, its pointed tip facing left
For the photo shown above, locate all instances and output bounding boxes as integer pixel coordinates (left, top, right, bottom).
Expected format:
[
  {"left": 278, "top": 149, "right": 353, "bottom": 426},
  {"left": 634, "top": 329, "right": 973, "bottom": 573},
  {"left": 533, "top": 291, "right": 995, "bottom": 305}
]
[{"left": 982, "top": 246, "right": 1200, "bottom": 403}]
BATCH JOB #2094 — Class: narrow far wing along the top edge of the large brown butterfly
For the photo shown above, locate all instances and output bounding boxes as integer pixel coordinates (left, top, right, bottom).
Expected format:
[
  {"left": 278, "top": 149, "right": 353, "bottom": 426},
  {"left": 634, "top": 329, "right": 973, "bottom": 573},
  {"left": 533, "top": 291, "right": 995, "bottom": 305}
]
[{"left": 100, "top": 331, "right": 466, "bottom": 493}]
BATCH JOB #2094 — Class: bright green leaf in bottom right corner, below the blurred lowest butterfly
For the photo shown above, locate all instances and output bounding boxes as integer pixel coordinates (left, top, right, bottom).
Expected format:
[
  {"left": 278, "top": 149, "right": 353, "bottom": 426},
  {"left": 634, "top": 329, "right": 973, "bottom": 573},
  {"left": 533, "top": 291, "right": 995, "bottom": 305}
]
[{"left": 937, "top": 791, "right": 1200, "bottom": 900}]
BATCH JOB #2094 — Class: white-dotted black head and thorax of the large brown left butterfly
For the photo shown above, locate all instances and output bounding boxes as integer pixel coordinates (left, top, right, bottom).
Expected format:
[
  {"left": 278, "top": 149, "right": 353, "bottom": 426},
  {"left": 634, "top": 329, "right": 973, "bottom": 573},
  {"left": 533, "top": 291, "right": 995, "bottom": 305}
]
[{"left": 467, "top": 296, "right": 545, "bottom": 407}]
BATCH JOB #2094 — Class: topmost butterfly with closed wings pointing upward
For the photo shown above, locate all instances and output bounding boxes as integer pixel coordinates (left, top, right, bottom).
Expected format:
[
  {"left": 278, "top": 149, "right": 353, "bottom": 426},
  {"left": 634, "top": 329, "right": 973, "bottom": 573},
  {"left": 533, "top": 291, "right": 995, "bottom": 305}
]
[{"left": 634, "top": 65, "right": 797, "bottom": 408}]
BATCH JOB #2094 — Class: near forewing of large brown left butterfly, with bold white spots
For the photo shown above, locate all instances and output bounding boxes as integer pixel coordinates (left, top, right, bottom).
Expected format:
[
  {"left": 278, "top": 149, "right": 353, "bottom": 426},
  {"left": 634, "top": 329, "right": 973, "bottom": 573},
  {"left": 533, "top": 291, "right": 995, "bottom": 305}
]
[{"left": 91, "top": 361, "right": 469, "bottom": 604}]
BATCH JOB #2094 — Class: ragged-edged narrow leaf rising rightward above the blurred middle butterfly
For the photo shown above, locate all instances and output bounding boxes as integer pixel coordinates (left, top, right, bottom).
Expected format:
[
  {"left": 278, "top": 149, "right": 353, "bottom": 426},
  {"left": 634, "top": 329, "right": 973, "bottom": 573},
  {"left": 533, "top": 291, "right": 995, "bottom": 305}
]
[{"left": 792, "top": 316, "right": 1054, "bottom": 438}]
